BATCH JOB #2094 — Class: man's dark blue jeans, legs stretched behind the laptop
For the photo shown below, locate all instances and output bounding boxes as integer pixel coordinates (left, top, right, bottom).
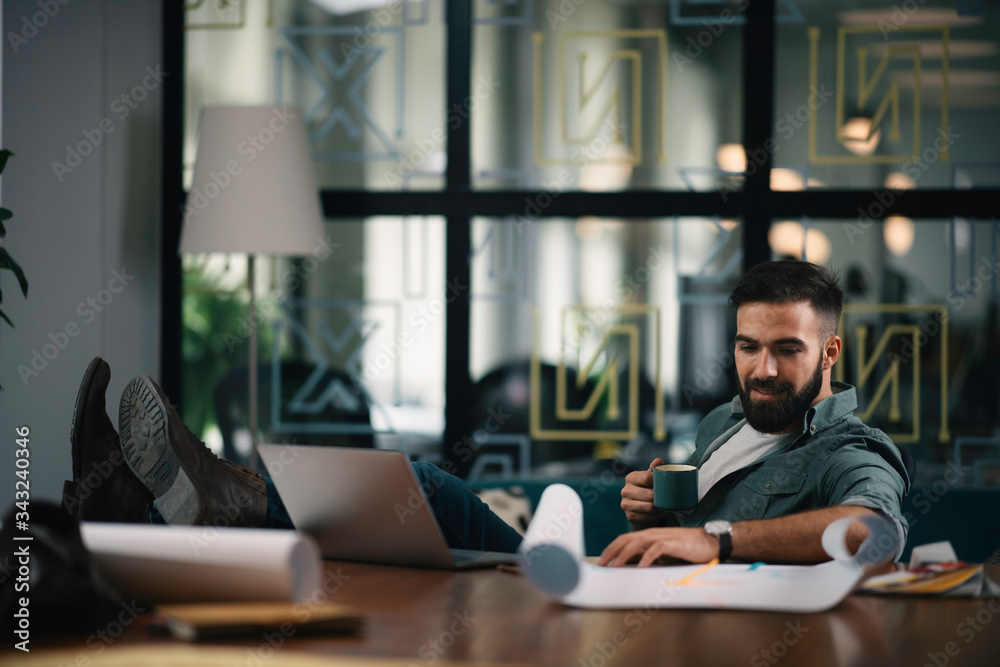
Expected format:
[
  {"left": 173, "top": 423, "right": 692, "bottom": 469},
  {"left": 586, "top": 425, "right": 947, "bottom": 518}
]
[{"left": 150, "top": 461, "right": 522, "bottom": 553}]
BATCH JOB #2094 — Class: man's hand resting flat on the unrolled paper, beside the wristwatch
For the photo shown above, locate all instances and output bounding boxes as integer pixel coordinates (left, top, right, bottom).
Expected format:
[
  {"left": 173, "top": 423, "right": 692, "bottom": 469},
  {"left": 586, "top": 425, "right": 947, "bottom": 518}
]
[{"left": 597, "top": 528, "right": 719, "bottom": 567}]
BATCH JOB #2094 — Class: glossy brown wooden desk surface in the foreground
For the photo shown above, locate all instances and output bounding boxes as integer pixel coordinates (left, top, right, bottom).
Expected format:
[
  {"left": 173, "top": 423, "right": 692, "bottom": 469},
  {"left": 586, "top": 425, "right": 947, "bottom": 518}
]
[{"left": 8, "top": 562, "right": 1000, "bottom": 667}]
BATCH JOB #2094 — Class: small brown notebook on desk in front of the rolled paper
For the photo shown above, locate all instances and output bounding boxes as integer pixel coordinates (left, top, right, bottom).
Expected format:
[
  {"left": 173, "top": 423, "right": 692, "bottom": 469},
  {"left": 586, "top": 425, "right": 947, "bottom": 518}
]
[{"left": 156, "top": 602, "right": 362, "bottom": 641}]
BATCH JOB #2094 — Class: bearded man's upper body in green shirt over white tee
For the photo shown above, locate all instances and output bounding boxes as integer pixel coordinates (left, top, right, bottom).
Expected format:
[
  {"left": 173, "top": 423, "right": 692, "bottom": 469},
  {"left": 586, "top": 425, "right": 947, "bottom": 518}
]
[{"left": 599, "top": 261, "right": 911, "bottom": 566}]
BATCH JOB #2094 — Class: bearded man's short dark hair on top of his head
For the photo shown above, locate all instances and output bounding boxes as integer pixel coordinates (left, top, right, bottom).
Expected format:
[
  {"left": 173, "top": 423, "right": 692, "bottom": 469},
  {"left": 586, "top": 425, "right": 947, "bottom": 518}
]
[{"left": 729, "top": 259, "right": 844, "bottom": 338}]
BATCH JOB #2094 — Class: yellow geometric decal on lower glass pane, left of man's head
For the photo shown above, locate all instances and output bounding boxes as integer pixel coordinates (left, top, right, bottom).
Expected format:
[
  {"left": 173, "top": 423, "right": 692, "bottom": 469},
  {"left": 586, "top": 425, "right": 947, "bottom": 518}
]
[{"left": 531, "top": 304, "right": 666, "bottom": 441}]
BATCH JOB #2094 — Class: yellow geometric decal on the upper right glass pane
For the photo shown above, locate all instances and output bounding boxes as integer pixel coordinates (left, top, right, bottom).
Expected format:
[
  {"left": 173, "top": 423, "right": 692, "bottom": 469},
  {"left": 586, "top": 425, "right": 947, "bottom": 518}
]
[{"left": 807, "top": 25, "right": 949, "bottom": 164}]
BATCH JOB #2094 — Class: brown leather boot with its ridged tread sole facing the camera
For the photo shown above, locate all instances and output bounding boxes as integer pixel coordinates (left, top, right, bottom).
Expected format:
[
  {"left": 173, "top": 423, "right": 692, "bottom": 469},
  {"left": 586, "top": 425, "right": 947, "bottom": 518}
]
[{"left": 118, "top": 375, "right": 267, "bottom": 527}]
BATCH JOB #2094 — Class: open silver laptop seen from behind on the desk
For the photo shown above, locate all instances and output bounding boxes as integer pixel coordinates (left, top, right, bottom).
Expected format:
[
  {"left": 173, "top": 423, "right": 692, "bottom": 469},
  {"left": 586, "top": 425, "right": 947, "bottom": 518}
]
[{"left": 257, "top": 445, "right": 515, "bottom": 570}]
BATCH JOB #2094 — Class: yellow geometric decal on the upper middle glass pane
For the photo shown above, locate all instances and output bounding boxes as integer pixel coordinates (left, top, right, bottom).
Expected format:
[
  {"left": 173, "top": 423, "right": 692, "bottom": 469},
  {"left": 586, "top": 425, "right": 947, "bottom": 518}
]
[{"left": 532, "top": 30, "right": 667, "bottom": 166}]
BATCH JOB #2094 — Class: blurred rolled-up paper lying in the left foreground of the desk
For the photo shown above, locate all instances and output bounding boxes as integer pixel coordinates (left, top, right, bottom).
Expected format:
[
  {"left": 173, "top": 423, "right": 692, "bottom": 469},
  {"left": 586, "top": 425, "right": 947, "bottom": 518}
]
[{"left": 80, "top": 522, "right": 323, "bottom": 603}]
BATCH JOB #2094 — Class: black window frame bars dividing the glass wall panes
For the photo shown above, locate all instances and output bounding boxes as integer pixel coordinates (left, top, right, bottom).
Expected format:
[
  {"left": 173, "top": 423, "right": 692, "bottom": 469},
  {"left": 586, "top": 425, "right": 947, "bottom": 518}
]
[{"left": 160, "top": 0, "right": 1000, "bottom": 470}]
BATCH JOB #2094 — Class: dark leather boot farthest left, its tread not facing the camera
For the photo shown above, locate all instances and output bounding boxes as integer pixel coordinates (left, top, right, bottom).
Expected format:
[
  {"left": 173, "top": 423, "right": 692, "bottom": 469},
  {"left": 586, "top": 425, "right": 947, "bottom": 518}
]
[{"left": 62, "top": 357, "right": 153, "bottom": 523}]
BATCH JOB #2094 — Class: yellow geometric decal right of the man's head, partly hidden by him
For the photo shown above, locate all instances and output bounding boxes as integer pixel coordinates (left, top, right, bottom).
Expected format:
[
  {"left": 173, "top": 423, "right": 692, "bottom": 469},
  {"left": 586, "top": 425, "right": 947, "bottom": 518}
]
[{"left": 834, "top": 303, "right": 951, "bottom": 443}]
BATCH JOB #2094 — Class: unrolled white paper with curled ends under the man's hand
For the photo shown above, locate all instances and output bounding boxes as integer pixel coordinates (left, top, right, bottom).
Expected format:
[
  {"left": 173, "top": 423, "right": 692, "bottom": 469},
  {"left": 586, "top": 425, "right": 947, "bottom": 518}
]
[{"left": 518, "top": 484, "right": 899, "bottom": 613}]
